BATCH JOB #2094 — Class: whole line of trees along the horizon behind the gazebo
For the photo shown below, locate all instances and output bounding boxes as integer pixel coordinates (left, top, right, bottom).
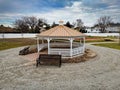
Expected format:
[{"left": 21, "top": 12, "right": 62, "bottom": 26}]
[{"left": 0, "top": 16, "right": 119, "bottom": 33}]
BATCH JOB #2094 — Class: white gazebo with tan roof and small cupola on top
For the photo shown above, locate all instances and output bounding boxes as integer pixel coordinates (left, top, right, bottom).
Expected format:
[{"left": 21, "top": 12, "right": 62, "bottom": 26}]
[{"left": 37, "top": 21, "right": 85, "bottom": 58}]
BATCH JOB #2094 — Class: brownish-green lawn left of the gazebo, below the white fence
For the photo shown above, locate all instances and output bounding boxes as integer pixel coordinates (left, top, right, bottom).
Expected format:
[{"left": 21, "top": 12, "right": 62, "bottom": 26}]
[{"left": 0, "top": 38, "right": 36, "bottom": 50}]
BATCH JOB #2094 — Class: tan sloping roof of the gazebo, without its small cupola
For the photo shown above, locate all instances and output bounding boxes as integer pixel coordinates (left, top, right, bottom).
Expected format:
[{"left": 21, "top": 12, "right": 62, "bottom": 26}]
[{"left": 37, "top": 25, "right": 85, "bottom": 37}]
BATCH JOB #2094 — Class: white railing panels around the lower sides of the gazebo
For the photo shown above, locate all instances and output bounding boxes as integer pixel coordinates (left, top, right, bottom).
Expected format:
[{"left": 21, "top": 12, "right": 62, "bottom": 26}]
[{"left": 39, "top": 43, "right": 84, "bottom": 57}]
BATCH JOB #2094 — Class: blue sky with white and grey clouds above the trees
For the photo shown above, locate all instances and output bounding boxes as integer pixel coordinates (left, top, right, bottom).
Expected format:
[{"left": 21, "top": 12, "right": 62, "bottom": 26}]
[{"left": 0, "top": 0, "right": 120, "bottom": 26}]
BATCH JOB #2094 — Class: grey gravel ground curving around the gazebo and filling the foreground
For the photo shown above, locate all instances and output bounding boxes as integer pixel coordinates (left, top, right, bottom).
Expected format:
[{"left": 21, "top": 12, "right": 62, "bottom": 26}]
[{"left": 0, "top": 44, "right": 120, "bottom": 90}]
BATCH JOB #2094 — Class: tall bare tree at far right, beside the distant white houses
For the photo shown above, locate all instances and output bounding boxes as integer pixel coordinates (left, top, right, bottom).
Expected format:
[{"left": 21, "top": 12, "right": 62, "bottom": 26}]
[{"left": 98, "top": 16, "right": 112, "bottom": 33}]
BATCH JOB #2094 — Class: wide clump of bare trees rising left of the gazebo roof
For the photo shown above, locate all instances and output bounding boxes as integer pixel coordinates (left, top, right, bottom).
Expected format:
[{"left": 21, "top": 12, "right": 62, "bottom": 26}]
[{"left": 14, "top": 16, "right": 49, "bottom": 33}]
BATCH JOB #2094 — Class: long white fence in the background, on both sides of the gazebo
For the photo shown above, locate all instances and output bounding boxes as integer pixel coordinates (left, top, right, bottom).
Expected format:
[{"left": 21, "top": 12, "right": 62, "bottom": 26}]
[{"left": 0, "top": 33, "right": 119, "bottom": 38}]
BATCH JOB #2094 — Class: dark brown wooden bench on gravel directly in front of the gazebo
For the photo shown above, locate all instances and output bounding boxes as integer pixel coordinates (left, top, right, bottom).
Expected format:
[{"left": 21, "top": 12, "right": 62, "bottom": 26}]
[{"left": 36, "top": 54, "right": 61, "bottom": 67}]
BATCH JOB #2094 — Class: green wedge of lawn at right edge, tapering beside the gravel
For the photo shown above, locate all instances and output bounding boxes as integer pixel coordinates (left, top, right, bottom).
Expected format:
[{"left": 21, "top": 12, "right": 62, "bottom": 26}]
[{"left": 93, "top": 43, "right": 120, "bottom": 50}]
